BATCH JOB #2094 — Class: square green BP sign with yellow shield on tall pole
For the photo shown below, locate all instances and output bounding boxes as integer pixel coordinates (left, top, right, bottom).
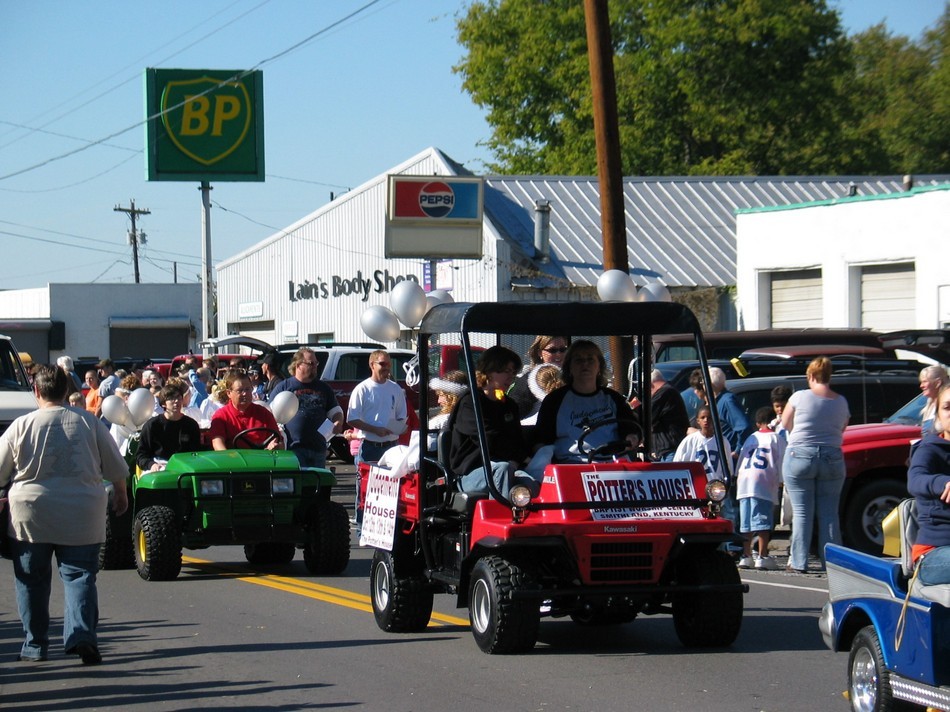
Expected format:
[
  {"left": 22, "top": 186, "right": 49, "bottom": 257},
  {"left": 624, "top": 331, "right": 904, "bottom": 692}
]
[{"left": 145, "top": 69, "right": 264, "bottom": 181}]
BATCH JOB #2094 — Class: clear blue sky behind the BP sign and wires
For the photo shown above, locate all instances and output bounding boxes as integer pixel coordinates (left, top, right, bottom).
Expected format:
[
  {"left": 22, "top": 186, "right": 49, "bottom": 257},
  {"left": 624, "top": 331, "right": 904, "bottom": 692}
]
[{"left": 0, "top": 0, "right": 943, "bottom": 290}]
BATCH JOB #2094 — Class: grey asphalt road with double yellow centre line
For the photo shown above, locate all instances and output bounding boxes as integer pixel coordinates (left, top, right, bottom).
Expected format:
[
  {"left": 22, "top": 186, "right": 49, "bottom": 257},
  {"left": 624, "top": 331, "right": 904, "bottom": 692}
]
[{"left": 0, "top": 464, "right": 847, "bottom": 712}]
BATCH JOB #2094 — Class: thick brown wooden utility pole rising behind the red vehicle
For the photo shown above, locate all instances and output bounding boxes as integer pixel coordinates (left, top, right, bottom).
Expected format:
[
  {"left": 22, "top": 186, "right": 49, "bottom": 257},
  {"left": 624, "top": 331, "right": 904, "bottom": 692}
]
[{"left": 584, "top": 0, "right": 633, "bottom": 393}]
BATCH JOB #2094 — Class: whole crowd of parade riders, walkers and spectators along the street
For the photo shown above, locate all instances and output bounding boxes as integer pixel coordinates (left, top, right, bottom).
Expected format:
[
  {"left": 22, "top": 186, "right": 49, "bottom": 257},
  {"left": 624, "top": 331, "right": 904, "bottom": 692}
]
[{"left": 0, "top": 335, "right": 950, "bottom": 664}]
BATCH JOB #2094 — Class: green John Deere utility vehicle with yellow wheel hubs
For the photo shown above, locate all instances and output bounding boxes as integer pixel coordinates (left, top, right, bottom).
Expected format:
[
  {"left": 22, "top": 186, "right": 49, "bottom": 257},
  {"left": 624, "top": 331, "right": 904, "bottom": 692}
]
[{"left": 125, "top": 449, "right": 350, "bottom": 581}]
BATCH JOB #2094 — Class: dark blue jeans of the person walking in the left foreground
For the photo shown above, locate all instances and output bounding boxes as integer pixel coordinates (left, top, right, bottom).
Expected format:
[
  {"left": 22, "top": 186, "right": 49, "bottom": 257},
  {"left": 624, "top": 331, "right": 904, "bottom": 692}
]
[{"left": 11, "top": 540, "right": 99, "bottom": 660}]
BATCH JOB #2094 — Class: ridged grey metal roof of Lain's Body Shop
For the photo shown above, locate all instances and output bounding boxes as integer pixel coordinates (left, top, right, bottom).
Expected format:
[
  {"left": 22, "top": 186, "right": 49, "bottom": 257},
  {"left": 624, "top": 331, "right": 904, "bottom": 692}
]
[{"left": 485, "top": 176, "right": 950, "bottom": 287}]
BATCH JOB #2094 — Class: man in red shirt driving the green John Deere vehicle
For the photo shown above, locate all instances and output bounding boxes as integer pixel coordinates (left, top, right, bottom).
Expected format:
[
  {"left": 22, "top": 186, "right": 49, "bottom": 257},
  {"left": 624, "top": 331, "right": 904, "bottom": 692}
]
[{"left": 210, "top": 371, "right": 284, "bottom": 450}]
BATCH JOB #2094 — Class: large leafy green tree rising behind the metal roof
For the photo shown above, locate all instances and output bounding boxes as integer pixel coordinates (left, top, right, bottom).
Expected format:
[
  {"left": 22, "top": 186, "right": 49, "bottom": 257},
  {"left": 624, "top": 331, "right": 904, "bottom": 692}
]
[{"left": 455, "top": 0, "right": 950, "bottom": 175}]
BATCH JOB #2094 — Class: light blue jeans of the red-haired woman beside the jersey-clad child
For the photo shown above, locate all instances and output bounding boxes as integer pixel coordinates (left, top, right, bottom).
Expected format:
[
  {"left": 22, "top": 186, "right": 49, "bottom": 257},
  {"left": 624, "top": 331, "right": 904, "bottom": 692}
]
[{"left": 782, "top": 445, "right": 845, "bottom": 569}]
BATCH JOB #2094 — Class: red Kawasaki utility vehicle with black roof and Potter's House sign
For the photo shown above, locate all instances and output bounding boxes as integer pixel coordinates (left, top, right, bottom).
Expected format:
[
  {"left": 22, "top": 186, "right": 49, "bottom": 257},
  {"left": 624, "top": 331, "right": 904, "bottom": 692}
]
[{"left": 361, "top": 302, "right": 748, "bottom": 653}]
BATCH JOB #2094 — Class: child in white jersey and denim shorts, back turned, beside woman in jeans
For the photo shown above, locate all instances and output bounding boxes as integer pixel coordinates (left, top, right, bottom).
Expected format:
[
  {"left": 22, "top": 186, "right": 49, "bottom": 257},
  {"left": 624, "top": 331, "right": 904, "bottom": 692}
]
[{"left": 736, "top": 406, "right": 785, "bottom": 571}]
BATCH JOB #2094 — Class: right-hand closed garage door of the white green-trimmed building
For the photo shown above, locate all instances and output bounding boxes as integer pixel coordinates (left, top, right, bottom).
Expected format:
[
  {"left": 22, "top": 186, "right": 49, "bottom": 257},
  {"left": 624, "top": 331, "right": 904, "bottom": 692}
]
[{"left": 861, "top": 262, "right": 917, "bottom": 331}]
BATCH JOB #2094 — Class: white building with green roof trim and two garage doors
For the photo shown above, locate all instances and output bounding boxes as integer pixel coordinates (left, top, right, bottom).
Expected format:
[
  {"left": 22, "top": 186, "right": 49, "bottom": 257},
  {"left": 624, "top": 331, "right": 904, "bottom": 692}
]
[{"left": 737, "top": 185, "right": 950, "bottom": 331}]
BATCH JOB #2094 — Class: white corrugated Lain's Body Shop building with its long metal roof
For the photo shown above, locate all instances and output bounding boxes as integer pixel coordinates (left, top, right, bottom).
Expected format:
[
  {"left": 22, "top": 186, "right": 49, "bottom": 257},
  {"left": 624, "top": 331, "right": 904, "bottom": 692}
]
[{"left": 217, "top": 148, "right": 950, "bottom": 343}]
